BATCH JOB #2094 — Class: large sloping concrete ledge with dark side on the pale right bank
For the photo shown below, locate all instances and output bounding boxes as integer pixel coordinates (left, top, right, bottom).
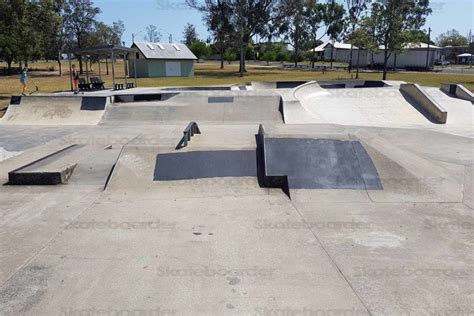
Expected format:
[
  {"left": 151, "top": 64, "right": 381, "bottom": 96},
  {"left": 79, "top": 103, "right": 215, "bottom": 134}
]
[{"left": 400, "top": 83, "right": 448, "bottom": 124}]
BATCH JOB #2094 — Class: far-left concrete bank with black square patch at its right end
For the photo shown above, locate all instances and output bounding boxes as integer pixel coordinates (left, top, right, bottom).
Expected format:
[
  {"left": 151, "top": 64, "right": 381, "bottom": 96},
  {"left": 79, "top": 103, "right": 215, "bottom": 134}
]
[{"left": 0, "top": 96, "right": 109, "bottom": 126}]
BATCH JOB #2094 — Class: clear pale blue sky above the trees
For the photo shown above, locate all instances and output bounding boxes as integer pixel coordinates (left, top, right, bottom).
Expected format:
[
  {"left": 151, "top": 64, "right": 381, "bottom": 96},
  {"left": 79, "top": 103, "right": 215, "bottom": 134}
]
[{"left": 93, "top": 0, "right": 474, "bottom": 46}]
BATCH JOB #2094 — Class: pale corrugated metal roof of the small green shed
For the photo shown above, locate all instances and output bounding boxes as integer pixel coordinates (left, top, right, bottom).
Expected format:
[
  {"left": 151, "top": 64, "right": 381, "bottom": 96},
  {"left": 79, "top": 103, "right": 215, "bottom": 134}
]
[{"left": 132, "top": 42, "right": 197, "bottom": 60}]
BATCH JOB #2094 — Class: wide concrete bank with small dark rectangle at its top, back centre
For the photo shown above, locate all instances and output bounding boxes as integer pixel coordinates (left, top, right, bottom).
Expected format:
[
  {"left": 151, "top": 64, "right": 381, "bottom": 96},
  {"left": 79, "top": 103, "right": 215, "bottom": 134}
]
[{"left": 101, "top": 91, "right": 283, "bottom": 125}]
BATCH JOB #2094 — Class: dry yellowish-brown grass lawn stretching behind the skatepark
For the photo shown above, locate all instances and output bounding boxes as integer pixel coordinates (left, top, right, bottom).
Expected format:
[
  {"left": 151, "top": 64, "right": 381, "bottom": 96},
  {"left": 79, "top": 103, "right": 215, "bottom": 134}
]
[{"left": 0, "top": 62, "right": 474, "bottom": 116}]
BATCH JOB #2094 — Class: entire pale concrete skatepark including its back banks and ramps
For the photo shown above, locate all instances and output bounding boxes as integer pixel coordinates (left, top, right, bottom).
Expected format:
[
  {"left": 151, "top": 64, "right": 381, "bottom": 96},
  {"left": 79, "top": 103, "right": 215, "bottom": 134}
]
[{"left": 0, "top": 82, "right": 474, "bottom": 315}]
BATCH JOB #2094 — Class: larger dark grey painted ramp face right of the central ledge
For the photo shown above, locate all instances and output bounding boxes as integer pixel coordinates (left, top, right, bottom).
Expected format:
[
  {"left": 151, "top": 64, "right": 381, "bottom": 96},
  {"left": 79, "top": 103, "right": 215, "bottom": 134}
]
[{"left": 265, "top": 138, "right": 383, "bottom": 190}]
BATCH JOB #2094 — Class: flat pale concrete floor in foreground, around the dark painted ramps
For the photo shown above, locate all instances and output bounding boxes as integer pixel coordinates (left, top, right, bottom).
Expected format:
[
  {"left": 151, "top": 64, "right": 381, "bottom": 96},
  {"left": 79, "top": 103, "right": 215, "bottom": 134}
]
[{"left": 0, "top": 84, "right": 474, "bottom": 315}]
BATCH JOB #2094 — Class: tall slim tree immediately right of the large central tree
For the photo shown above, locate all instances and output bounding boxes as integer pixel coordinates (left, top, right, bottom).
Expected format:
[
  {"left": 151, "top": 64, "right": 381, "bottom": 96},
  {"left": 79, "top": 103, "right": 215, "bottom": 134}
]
[{"left": 274, "top": 0, "right": 311, "bottom": 68}]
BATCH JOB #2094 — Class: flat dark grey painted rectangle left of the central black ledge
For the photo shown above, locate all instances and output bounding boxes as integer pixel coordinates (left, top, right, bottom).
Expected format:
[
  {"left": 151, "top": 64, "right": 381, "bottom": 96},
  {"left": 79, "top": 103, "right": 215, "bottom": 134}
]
[{"left": 154, "top": 150, "right": 257, "bottom": 181}]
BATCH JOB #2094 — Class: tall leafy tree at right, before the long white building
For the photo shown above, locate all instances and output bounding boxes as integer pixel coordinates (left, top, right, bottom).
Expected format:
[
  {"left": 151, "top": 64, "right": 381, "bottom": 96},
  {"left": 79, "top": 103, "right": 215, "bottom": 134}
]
[{"left": 368, "top": 0, "right": 431, "bottom": 80}]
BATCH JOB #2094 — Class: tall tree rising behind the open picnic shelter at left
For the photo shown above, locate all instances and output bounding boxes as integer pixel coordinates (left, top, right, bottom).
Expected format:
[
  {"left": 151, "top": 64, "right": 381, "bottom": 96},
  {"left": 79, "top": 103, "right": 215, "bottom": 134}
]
[{"left": 64, "top": 0, "right": 101, "bottom": 73}]
